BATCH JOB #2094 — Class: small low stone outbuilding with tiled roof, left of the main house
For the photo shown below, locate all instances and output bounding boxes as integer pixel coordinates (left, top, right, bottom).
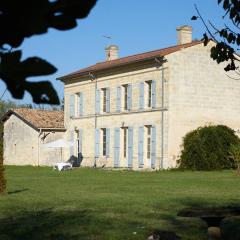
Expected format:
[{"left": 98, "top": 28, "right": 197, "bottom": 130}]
[{"left": 1, "top": 108, "right": 65, "bottom": 166}]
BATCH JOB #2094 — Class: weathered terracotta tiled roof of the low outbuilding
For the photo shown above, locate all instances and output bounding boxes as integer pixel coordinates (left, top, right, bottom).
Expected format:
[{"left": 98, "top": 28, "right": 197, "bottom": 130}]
[{"left": 2, "top": 108, "right": 64, "bottom": 129}]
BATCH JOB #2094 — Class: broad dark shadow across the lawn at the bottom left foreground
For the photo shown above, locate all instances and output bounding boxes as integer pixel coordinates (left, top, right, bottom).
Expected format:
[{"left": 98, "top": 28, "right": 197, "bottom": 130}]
[{"left": 0, "top": 209, "right": 150, "bottom": 240}]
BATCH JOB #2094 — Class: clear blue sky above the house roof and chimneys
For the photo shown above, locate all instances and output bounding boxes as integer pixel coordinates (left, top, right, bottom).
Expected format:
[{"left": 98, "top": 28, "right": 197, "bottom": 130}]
[{"left": 0, "top": 0, "right": 227, "bottom": 104}]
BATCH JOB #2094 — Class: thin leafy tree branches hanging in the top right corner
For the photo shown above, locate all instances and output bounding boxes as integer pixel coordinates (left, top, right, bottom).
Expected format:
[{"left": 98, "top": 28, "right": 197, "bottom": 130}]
[{"left": 192, "top": 0, "right": 240, "bottom": 74}]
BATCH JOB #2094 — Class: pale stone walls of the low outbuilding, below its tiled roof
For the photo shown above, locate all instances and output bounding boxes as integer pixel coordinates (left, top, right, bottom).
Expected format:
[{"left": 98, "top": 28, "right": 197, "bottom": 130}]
[{"left": 3, "top": 114, "right": 64, "bottom": 166}]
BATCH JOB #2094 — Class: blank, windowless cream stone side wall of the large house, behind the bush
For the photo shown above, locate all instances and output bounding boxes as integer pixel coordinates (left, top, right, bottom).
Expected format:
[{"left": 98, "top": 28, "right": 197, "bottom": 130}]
[{"left": 168, "top": 43, "right": 240, "bottom": 167}]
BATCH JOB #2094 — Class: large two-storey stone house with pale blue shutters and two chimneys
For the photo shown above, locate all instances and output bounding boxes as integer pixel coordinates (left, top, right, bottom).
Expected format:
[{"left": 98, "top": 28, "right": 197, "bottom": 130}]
[{"left": 56, "top": 26, "right": 240, "bottom": 169}]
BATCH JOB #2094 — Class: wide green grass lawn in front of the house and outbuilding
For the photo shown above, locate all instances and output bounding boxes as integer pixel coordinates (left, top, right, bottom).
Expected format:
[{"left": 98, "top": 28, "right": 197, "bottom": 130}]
[{"left": 0, "top": 167, "right": 240, "bottom": 240}]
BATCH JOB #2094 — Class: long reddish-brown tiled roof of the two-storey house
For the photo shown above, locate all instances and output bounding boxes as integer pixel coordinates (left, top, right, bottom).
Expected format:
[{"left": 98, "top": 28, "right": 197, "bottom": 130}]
[{"left": 58, "top": 41, "right": 202, "bottom": 80}]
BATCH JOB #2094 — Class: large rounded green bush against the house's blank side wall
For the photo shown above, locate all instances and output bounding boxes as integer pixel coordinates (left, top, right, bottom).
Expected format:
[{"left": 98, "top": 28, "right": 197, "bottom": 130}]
[{"left": 179, "top": 125, "right": 239, "bottom": 170}]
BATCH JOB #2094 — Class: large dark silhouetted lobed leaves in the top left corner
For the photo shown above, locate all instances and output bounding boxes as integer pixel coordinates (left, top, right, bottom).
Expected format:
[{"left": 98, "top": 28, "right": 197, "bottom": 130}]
[{"left": 0, "top": 0, "right": 97, "bottom": 104}]
